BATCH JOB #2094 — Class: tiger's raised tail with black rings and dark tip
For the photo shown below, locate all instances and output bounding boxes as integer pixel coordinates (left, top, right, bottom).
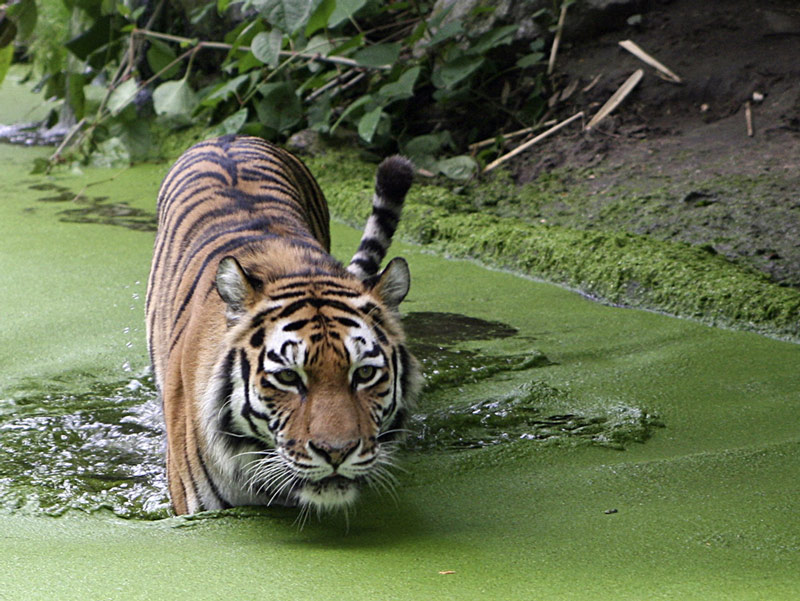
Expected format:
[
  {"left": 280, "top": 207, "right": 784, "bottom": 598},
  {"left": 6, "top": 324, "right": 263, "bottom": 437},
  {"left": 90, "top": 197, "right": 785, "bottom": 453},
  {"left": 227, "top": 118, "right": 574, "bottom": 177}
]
[{"left": 347, "top": 155, "right": 414, "bottom": 280}]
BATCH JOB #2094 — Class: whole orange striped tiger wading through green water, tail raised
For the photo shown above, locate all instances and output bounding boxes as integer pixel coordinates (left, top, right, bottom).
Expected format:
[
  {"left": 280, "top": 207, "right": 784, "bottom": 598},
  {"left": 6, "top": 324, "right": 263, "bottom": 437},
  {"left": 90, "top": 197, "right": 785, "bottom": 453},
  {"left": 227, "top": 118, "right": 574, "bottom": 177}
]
[{"left": 145, "top": 135, "right": 421, "bottom": 515}]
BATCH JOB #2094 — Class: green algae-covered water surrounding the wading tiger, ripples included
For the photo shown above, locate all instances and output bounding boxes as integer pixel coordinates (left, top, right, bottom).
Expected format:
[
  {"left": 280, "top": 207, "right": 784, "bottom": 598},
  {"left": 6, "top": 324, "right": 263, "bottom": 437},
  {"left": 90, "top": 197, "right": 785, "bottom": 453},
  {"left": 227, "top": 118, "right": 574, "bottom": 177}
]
[{"left": 0, "top": 77, "right": 800, "bottom": 601}]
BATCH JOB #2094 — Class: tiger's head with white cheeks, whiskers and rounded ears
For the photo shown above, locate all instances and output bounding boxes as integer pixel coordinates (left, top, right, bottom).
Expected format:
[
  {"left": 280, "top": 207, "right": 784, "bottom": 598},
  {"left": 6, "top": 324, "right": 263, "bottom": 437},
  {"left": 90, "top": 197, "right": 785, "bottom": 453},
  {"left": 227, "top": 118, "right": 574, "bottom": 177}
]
[{"left": 203, "top": 257, "right": 421, "bottom": 510}]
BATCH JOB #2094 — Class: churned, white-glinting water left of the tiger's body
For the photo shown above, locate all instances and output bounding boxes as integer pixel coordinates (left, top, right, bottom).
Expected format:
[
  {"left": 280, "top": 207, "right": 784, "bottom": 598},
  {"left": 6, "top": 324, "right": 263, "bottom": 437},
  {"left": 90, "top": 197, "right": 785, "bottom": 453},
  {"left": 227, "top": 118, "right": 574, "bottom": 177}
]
[{"left": 0, "top": 380, "right": 169, "bottom": 519}]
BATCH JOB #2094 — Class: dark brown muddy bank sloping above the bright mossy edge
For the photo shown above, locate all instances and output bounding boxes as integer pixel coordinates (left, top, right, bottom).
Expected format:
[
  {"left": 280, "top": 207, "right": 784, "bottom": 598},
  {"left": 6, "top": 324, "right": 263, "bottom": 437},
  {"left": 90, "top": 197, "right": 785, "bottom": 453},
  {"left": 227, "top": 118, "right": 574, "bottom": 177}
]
[{"left": 506, "top": 0, "right": 800, "bottom": 288}]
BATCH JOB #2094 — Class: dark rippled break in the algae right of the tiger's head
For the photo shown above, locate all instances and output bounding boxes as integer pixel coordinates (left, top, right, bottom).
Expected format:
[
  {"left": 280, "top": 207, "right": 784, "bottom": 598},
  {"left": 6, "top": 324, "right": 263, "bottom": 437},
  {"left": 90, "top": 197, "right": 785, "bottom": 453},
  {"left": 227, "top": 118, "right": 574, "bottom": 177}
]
[{"left": 404, "top": 313, "right": 662, "bottom": 450}]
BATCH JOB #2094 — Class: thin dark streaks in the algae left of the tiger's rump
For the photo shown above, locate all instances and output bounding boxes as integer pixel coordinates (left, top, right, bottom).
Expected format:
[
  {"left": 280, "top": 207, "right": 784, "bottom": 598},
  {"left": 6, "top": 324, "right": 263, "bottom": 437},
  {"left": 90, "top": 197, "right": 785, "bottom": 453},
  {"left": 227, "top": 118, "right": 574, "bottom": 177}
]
[{"left": 28, "top": 183, "right": 157, "bottom": 232}]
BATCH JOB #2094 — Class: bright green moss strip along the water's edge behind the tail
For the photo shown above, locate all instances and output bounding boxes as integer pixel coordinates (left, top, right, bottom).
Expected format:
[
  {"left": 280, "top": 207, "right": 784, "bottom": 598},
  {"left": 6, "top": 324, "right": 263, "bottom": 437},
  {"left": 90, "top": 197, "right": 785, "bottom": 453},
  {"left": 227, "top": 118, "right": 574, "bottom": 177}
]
[{"left": 308, "top": 151, "right": 800, "bottom": 340}]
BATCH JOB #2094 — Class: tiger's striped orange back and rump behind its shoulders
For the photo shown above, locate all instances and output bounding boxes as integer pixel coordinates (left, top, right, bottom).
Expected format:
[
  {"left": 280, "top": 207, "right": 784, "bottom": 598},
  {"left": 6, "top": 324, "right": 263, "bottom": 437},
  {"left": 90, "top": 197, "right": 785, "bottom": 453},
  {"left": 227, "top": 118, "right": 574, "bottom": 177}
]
[{"left": 146, "top": 136, "right": 330, "bottom": 387}]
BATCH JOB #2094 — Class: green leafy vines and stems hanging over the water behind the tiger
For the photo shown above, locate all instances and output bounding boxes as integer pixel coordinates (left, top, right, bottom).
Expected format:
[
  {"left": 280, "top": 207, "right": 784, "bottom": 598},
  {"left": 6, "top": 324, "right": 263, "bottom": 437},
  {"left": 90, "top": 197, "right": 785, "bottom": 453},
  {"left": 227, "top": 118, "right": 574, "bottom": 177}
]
[{"left": 0, "top": 0, "right": 560, "bottom": 179}]
